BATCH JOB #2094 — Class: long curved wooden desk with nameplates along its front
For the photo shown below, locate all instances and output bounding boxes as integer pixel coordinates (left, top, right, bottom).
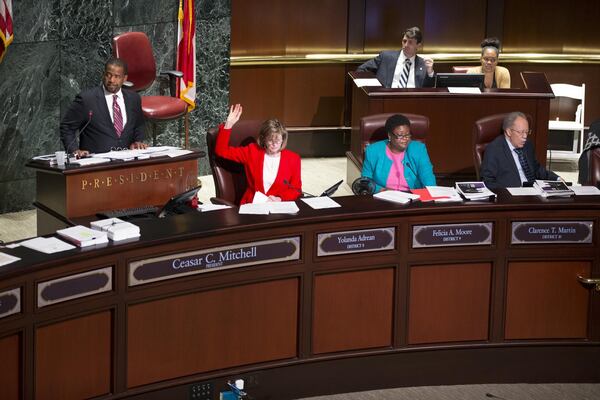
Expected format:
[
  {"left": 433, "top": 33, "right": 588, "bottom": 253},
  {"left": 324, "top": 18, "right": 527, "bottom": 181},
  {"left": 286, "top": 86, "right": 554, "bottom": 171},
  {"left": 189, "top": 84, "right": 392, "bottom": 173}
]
[{"left": 0, "top": 192, "right": 600, "bottom": 400}]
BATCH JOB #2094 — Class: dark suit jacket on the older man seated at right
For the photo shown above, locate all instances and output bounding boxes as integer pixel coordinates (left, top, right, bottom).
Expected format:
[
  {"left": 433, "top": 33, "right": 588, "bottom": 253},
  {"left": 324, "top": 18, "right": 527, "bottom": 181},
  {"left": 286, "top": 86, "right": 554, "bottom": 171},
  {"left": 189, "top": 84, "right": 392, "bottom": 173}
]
[{"left": 480, "top": 134, "right": 558, "bottom": 189}]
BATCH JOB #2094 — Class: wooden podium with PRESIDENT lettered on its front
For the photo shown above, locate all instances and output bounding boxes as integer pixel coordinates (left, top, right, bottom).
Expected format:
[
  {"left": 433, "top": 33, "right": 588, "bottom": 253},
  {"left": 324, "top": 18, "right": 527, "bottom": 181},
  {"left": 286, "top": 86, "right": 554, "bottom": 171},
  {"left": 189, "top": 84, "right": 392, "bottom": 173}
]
[{"left": 26, "top": 151, "right": 204, "bottom": 235}]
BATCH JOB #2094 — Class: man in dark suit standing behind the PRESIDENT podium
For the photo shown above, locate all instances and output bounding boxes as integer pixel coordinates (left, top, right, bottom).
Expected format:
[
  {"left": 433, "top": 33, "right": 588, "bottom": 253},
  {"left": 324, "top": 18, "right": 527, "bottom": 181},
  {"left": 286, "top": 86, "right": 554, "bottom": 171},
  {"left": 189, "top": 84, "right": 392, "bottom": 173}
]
[{"left": 60, "top": 58, "right": 148, "bottom": 157}]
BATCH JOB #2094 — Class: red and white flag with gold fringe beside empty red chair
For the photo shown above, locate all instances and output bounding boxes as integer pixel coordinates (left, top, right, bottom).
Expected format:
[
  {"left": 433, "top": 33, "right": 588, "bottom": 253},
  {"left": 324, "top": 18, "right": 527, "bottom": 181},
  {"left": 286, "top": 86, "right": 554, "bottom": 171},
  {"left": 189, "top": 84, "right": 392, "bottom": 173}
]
[{"left": 176, "top": 0, "right": 196, "bottom": 111}]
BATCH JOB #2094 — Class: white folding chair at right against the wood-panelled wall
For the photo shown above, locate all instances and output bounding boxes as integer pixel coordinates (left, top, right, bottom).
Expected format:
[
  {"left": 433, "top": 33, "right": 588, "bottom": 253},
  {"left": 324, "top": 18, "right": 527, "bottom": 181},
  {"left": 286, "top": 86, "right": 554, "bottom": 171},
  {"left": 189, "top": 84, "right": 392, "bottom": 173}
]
[{"left": 548, "top": 83, "right": 585, "bottom": 156}]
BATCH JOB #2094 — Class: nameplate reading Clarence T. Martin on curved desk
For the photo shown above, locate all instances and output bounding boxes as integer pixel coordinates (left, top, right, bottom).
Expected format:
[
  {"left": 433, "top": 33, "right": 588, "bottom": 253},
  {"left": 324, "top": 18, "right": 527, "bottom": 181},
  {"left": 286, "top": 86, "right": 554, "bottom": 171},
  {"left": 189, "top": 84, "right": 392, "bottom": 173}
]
[{"left": 510, "top": 221, "right": 594, "bottom": 244}]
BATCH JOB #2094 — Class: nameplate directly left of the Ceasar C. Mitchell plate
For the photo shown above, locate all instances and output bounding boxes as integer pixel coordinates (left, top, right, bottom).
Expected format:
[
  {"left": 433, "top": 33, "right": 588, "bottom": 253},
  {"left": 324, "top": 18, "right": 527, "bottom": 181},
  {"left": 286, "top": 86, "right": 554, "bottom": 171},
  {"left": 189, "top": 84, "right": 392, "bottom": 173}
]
[{"left": 37, "top": 267, "right": 112, "bottom": 308}]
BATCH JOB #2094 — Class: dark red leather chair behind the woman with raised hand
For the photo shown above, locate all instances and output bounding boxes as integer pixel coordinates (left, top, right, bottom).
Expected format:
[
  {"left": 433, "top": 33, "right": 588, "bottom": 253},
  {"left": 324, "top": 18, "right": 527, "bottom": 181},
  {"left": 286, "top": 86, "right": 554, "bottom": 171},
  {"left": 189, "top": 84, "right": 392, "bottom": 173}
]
[{"left": 206, "top": 120, "right": 262, "bottom": 205}]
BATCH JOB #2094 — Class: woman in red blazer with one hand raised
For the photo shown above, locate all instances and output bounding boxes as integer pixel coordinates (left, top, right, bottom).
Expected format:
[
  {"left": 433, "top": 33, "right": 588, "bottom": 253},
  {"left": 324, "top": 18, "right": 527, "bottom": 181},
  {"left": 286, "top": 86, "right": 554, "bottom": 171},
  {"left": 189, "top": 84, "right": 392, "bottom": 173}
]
[{"left": 215, "top": 104, "right": 302, "bottom": 204}]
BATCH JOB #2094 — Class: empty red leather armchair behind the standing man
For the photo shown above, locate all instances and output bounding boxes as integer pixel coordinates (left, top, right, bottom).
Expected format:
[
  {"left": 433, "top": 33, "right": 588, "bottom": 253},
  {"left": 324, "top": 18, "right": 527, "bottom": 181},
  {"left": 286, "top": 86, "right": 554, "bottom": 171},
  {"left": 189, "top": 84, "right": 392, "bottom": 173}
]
[{"left": 113, "top": 32, "right": 189, "bottom": 148}]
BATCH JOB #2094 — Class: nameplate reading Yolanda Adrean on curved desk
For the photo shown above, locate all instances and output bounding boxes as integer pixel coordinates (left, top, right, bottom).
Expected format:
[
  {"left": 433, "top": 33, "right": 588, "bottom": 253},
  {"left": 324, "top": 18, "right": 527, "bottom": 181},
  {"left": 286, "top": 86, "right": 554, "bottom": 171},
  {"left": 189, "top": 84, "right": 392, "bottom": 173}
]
[{"left": 317, "top": 227, "right": 396, "bottom": 257}]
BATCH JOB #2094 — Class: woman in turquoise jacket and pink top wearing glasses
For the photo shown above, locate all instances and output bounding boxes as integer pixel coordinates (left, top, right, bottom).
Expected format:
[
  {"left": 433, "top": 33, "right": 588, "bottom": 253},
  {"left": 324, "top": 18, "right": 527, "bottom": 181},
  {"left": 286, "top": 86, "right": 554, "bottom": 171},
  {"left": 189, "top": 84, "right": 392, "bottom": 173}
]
[{"left": 362, "top": 114, "right": 435, "bottom": 192}]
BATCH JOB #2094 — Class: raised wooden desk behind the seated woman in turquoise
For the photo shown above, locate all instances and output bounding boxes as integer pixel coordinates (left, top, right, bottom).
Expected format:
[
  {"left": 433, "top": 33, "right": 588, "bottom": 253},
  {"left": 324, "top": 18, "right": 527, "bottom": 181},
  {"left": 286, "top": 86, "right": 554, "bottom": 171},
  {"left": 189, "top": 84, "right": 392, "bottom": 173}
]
[{"left": 347, "top": 72, "right": 554, "bottom": 182}]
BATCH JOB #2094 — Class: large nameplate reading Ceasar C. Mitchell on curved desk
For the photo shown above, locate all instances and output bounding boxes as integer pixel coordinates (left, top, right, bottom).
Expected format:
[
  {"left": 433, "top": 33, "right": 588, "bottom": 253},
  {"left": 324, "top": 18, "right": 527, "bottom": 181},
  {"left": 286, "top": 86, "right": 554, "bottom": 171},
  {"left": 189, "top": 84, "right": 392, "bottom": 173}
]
[{"left": 129, "top": 236, "right": 300, "bottom": 286}]
